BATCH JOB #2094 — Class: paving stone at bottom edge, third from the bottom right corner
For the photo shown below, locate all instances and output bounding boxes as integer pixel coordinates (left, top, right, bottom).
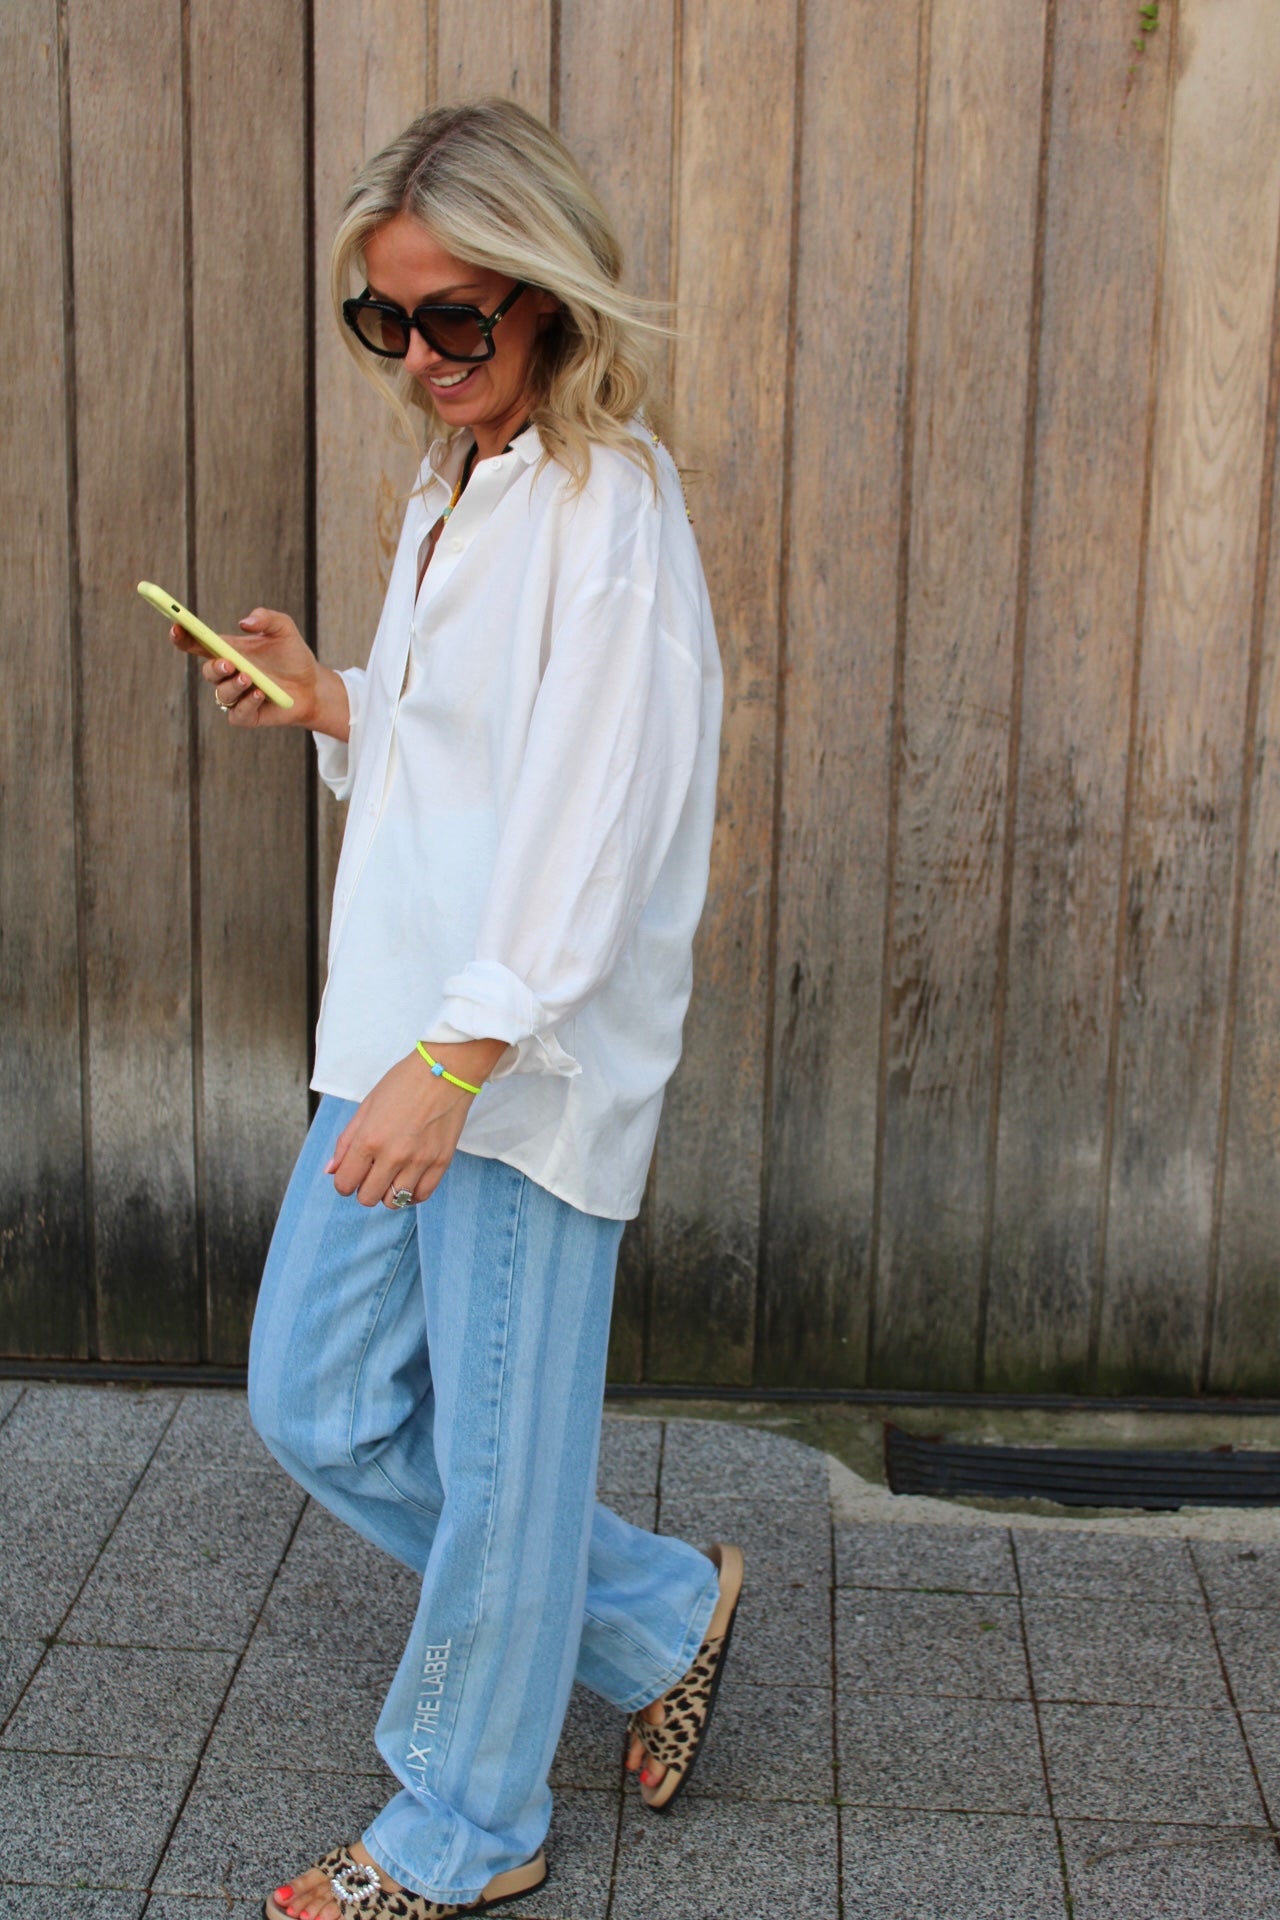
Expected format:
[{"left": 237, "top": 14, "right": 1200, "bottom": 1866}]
[{"left": 612, "top": 1799, "right": 839, "bottom": 1920}]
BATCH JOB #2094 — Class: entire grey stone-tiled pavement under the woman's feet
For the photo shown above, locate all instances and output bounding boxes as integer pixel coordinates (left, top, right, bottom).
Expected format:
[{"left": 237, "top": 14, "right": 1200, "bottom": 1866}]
[{"left": 0, "top": 1382, "right": 1280, "bottom": 1920}]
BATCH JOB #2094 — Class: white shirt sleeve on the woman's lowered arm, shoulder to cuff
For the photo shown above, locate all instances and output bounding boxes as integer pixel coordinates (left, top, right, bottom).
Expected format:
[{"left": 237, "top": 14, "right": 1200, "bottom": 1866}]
[{"left": 428, "top": 497, "right": 702, "bottom": 1077}]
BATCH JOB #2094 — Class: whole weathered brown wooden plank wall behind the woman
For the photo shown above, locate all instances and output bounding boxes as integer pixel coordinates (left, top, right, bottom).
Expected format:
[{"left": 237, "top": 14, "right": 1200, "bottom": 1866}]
[{"left": 0, "top": 0, "right": 1280, "bottom": 1392}]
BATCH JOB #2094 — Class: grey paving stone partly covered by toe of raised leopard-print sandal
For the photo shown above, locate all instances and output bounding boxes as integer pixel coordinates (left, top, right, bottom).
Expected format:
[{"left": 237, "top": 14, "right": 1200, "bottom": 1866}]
[{"left": 685, "top": 1668, "right": 835, "bottom": 1805}]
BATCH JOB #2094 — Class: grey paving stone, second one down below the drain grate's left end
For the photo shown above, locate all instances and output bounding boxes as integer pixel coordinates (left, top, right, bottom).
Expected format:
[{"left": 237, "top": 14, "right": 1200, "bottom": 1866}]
[{"left": 835, "top": 1588, "right": 1031, "bottom": 1699}]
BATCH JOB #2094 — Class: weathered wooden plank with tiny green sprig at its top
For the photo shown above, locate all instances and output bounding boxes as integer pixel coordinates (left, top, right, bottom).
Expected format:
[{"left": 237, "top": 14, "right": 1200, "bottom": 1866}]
[{"left": 983, "top": 0, "right": 1171, "bottom": 1392}]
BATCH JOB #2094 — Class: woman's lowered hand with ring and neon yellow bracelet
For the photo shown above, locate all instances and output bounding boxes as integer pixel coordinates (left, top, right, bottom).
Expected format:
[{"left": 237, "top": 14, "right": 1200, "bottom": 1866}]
[{"left": 324, "top": 1041, "right": 507, "bottom": 1206}]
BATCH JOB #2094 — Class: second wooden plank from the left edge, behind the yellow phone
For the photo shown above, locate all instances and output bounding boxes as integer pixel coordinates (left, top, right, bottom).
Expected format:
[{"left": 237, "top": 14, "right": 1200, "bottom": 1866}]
[{"left": 67, "top": 0, "right": 196, "bottom": 1359}]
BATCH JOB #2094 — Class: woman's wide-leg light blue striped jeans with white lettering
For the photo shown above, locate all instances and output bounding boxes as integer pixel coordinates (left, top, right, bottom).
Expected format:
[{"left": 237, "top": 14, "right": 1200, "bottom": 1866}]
[{"left": 249, "top": 1094, "right": 718, "bottom": 1905}]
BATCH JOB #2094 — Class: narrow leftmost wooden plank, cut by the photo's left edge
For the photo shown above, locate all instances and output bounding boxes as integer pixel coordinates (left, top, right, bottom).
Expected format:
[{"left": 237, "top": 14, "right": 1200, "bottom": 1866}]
[{"left": 0, "top": 0, "right": 88, "bottom": 1356}]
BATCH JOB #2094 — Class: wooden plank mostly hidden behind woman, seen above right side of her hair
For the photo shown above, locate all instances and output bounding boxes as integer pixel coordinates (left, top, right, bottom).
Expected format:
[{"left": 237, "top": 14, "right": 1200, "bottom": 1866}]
[{"left": 558, "top": 0, "right": 676, "bottom": 1380}]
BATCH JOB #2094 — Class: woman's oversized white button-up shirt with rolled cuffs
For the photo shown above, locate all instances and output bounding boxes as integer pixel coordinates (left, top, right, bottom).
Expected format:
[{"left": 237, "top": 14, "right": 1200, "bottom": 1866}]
[{"left": 311, "top": 428, "right": 722, "bottom": 1219}]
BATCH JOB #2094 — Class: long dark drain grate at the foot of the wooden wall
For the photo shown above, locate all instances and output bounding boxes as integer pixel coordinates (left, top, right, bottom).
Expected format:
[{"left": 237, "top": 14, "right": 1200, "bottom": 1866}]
[{"left": 885, "top": 1421, "right": 1280, "bottom": 1513}]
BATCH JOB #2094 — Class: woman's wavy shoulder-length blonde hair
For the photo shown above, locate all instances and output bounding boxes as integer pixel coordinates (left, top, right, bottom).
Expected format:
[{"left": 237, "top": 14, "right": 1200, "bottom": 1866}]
[{"left": 330, "top": 100, "right": 668, "bottom": 486}]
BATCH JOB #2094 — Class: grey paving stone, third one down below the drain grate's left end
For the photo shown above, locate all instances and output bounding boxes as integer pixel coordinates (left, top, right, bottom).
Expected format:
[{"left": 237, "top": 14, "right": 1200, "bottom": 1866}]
[{"left": 837, "top": 1693, "right": 1050, "bottom": 1814}]
